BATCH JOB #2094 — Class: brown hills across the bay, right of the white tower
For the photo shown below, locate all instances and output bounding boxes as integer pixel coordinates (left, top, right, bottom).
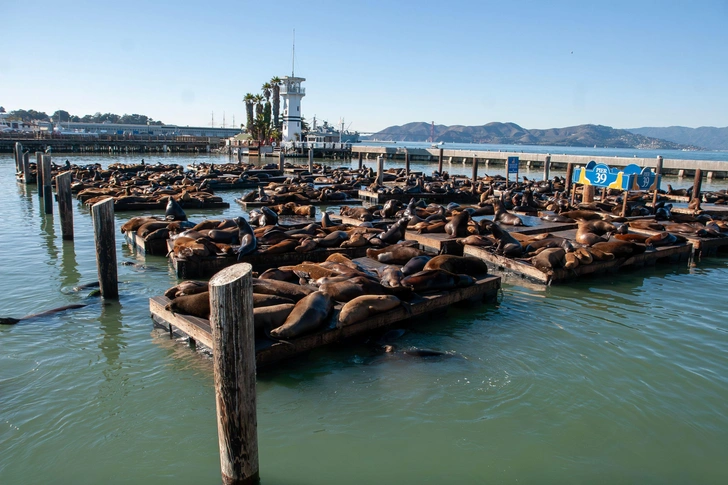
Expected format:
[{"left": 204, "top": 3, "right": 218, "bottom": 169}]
[{"left": 370, "top": 122, "right": 699, "bottom": 150}]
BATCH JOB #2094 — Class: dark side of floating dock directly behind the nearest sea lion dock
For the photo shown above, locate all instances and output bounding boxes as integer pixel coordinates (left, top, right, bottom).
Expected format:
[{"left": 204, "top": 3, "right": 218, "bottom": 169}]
[{"left": 170, "top": 246, "right": 370, "bottom": 279}]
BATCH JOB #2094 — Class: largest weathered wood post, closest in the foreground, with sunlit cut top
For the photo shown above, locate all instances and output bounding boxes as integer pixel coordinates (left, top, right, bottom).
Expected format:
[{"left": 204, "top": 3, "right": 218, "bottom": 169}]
[{"left": 210, "top": 263, "right": 259, "bottom": 485}]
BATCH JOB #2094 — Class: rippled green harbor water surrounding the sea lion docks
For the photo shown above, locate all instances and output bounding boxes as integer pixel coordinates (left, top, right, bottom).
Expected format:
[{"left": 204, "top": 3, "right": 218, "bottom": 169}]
[{"left": 0, "top": 154, "right": 728, "bottom": 485}]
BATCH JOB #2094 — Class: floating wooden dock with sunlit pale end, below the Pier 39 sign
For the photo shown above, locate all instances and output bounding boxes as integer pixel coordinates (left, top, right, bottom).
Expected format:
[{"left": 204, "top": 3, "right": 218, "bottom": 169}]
[{"left": 463, "top": 231, "right": 693, "bottom": 285}]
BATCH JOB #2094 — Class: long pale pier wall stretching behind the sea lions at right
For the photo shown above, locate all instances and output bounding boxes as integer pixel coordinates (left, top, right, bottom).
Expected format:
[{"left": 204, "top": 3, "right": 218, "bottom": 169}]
[{"left": 351, "top": 145, "right": 728, "bottom": 180}]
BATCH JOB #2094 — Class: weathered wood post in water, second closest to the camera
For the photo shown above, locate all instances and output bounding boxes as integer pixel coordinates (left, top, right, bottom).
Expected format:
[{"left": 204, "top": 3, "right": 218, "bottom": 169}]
[{"left": 91, "top": 197, "right": 119, "bottom": 300}]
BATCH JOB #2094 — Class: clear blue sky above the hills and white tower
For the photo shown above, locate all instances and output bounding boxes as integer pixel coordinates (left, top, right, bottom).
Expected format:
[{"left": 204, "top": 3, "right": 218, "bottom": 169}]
[{"left": 0, "top": 0, "right": 728, "bottom": 131}]
